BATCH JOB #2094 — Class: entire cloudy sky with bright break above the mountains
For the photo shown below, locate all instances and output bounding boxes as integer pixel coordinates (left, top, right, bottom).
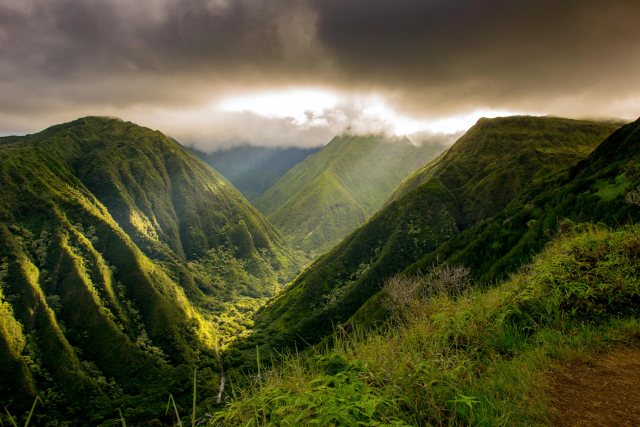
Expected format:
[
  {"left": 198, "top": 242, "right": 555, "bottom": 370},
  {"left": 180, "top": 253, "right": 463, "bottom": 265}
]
[{"left": 0, "top": 0, "right": 640, "bottom": 150}]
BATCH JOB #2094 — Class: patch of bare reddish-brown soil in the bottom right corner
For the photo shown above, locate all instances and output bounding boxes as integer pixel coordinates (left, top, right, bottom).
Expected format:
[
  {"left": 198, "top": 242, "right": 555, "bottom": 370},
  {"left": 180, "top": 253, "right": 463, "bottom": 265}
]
[{"left": 553, "top": 347, "right": 640, "bottom": 427}]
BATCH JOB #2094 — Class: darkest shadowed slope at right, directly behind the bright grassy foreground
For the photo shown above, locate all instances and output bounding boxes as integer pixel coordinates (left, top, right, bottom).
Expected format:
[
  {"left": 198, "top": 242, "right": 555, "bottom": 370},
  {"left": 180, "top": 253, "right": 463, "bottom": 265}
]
[{"left": 407, "top": 115, "right": 640, "bottom": 283}]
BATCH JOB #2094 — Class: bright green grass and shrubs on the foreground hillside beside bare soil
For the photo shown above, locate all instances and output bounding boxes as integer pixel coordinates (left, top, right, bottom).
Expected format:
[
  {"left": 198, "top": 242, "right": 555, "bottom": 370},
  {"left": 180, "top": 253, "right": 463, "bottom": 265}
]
[{"left": 217, "top": 222, "right": 640, "bottom": 427}]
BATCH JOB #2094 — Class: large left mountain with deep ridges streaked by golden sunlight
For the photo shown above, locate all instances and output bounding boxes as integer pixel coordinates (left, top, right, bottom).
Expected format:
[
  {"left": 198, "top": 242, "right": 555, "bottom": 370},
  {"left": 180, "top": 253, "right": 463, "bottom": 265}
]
[{"left": 0, "top": 117, "right": 298, "bottom": 425}]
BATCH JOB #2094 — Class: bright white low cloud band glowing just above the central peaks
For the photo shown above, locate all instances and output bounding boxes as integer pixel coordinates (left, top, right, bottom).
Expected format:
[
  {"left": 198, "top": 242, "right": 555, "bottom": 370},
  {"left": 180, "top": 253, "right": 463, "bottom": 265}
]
[{"left": 131, "top": 99, "right": 480, "bottom": 152}]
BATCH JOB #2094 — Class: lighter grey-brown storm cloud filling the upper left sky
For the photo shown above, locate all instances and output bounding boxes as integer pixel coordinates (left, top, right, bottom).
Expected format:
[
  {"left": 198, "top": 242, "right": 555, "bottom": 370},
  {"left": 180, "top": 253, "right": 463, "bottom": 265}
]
[{"left": 0, "top": 0, "right": 318, "bottom": 110}]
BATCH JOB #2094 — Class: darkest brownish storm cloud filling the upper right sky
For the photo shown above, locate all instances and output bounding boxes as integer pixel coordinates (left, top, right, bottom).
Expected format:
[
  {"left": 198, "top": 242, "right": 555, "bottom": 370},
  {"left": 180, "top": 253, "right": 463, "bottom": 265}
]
[{"left": 314, "top": 0, "right": 640, "bottom": 115}]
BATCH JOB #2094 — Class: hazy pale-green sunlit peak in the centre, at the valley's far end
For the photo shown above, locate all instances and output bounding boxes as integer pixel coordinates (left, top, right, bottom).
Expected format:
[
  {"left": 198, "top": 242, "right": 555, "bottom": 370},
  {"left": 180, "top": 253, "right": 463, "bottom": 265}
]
[{"left": 254, "top": 135, "right": 444, "bottom": 256}]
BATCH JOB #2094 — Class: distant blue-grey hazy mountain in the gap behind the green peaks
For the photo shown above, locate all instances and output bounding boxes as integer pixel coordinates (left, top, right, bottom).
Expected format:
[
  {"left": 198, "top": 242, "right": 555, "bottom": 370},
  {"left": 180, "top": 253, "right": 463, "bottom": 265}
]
[{"left": 190, "top": 145, "right": 321, "bottom": 202}]
